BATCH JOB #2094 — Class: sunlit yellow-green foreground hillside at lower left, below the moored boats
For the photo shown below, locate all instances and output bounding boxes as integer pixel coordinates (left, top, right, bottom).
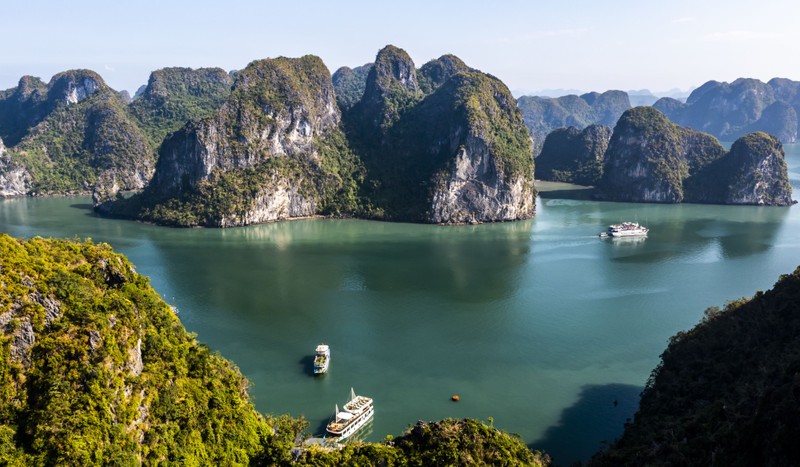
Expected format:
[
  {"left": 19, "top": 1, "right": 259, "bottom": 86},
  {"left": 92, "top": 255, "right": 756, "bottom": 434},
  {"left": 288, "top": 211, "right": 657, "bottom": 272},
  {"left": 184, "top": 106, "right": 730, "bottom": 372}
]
[{"left": 0, "top": 234, "right": 549, "bottom": 466}]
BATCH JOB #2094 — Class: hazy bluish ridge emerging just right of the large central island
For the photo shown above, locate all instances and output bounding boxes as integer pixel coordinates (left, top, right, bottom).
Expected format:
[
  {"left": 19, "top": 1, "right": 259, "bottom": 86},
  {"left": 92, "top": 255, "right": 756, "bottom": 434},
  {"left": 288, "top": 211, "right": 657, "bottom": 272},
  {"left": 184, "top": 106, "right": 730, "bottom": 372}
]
[{"left": 517, "top": 91, "right": 631, "bottom": 157}]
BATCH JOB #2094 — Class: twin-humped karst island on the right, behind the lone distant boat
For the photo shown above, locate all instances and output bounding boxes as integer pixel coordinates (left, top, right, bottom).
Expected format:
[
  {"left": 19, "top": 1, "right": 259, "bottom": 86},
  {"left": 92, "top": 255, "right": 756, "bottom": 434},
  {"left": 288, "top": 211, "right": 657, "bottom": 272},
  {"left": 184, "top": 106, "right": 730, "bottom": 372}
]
[{"left": 596, "top": 107, "right": 792, "bottom": 205}]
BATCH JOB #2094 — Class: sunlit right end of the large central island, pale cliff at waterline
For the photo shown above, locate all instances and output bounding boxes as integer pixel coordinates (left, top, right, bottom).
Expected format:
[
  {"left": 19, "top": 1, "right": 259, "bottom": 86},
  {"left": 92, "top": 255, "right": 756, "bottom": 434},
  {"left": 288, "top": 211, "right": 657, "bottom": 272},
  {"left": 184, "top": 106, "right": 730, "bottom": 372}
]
[{"left": 426, "top": 72, "right": 535, "bottom": 224}]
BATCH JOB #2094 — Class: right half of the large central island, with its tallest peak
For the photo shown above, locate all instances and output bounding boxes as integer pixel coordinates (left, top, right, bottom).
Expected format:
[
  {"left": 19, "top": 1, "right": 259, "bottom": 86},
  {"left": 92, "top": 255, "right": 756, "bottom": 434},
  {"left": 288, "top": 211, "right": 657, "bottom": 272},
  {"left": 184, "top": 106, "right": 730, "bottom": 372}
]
[{"left": 348, "top": 46, "right": 534, "bottom": 223}]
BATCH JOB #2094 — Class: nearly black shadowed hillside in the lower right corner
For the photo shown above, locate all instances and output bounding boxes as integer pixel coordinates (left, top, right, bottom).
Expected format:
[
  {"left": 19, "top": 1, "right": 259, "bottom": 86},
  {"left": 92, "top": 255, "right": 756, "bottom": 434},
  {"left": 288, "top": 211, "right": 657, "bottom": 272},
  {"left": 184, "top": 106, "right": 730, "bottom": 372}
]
[{"left": 591, "top": 268, "right": 800, "bottom": 466}]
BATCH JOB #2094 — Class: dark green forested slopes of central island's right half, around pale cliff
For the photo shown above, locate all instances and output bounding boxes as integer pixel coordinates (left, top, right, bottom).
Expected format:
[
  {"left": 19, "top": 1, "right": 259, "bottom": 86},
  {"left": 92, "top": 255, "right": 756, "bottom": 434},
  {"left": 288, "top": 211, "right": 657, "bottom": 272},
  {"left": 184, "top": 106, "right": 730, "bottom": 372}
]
[{"left": 343, "top": 46, "right": 533, "bottom": 222}]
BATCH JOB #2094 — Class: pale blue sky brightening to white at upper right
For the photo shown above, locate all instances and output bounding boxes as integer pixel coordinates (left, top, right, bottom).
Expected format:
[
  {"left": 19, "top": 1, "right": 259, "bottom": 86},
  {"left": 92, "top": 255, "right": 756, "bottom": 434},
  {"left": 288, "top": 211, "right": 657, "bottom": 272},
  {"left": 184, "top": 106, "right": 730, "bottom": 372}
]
[{"left": 0, "top": 0, "right": 800, "bottom": 95}]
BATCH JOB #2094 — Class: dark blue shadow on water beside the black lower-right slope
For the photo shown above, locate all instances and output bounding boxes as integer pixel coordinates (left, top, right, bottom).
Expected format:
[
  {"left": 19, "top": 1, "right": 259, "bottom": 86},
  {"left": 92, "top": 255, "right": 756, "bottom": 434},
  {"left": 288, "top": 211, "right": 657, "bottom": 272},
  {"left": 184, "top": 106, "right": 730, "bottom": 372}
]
[{"left": 530, "top": 384, "right": 643, "bottom": 466}]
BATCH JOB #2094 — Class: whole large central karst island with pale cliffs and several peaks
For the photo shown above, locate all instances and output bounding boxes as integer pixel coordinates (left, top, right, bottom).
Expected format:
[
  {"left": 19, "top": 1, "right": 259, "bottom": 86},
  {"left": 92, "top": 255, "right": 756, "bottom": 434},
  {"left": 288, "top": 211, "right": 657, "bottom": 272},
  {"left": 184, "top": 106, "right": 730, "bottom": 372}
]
[{"left": 96, "top": 46, "right": 535, "bottom": 227}]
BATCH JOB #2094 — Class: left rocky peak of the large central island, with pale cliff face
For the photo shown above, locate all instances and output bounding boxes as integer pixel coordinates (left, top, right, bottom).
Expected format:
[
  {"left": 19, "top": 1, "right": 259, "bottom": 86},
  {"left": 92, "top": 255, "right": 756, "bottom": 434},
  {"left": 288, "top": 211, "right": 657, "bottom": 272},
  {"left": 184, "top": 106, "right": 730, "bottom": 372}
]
[{"left": 148, "top": 55, "right": 341, "bottom": 200}]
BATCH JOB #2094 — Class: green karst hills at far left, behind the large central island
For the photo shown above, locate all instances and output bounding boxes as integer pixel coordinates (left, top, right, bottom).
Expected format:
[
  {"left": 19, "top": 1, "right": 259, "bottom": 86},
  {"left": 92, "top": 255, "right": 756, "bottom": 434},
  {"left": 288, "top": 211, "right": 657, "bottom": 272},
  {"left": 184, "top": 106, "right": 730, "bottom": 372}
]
[{"left": 0, "top": 68, "right": 231, "bottom": 196}]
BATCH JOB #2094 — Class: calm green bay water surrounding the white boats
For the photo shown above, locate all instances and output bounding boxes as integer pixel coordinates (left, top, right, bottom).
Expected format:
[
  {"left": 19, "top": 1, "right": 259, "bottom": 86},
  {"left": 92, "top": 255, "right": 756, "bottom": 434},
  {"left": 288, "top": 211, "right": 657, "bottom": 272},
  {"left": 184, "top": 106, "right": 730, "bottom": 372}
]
[{"left": 0, "top": 146, "right": 800, "bottom": 464}]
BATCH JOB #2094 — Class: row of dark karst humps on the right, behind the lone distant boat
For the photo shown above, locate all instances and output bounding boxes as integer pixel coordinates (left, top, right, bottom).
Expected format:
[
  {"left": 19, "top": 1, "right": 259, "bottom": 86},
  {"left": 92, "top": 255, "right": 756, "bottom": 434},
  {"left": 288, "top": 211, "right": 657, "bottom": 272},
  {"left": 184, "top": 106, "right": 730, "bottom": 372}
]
[{"left": 537, "top": 107, "right": 794, "bottom": 206}]
